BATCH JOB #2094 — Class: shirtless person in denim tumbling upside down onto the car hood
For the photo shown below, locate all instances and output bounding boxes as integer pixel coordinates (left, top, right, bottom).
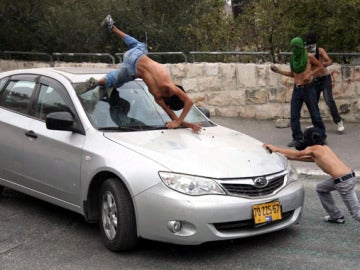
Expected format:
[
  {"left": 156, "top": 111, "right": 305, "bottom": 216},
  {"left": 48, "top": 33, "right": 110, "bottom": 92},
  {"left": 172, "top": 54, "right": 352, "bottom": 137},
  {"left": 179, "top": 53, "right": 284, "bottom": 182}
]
[{"left": 76, "top": 15, "right": 201, "bottom": 132}]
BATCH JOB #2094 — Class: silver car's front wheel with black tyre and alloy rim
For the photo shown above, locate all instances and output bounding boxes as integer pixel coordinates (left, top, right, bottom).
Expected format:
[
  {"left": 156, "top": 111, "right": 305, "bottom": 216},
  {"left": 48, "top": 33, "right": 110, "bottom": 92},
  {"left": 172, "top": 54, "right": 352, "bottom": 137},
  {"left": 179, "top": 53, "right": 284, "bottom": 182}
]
[{"left": 100, "top": 178, "right": 138, "bottom": 251}]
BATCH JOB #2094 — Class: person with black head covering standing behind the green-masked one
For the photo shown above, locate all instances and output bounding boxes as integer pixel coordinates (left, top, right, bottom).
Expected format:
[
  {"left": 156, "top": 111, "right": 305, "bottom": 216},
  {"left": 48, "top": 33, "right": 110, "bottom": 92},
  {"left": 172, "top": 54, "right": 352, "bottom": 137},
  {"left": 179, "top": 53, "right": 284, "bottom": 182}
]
[{"left": 305, "top": 32, "right": 345, "bottom": 132}]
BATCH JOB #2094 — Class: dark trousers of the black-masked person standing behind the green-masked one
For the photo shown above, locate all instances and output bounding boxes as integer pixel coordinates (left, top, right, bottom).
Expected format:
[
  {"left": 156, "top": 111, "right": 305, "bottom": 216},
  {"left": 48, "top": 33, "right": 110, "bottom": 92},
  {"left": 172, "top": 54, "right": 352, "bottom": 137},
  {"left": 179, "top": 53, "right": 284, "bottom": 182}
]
[{"left": 314, "top": 74, "right": 341, "bottom": 124}]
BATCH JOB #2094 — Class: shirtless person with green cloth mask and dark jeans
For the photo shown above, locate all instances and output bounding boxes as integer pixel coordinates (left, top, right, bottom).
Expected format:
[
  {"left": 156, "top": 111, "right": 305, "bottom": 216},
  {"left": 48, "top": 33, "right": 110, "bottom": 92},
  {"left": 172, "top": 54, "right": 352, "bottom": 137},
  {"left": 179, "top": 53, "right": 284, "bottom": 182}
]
[{"left": 271, "top": 37, "right": 326, "bottom": 147}]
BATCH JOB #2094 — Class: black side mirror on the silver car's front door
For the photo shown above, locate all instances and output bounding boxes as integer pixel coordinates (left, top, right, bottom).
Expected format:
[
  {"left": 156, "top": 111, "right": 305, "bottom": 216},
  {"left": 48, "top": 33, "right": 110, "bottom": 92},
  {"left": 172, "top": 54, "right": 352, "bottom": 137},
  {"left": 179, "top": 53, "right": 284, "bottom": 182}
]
[{"left": 45, "top": 112, "right": 76, "bottom": 131}]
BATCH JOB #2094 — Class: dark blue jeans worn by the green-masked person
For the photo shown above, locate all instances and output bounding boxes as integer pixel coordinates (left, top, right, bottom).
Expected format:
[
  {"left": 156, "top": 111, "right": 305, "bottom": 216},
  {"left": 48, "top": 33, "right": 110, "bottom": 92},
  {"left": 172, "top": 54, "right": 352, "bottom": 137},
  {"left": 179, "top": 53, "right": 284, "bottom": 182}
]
[{"left": 290, "top": 85, "right": 326, "bottom": 141}]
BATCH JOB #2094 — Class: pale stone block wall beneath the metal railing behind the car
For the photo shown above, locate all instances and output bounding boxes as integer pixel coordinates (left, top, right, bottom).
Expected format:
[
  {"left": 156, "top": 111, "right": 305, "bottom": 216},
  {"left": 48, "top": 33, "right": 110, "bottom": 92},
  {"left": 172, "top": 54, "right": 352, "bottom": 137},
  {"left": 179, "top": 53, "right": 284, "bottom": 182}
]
[{"left": 0, "top": 60, "right": 360, "bottom": 122}]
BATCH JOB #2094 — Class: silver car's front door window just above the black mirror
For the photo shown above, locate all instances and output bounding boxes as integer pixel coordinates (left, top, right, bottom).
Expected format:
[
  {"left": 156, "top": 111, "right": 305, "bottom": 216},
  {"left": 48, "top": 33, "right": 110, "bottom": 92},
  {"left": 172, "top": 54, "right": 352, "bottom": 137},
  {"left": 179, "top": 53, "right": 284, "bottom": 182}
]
[{"left": 35, "top": 84, "right": 70, "bottom": 120}]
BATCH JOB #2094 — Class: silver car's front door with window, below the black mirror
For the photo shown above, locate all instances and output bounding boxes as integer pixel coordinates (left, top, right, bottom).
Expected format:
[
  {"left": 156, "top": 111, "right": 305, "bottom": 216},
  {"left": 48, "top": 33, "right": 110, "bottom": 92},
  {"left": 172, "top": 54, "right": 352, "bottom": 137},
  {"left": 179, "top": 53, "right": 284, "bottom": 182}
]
[{"left": 22, "top": 77, "right": 85, "bottom": 206}]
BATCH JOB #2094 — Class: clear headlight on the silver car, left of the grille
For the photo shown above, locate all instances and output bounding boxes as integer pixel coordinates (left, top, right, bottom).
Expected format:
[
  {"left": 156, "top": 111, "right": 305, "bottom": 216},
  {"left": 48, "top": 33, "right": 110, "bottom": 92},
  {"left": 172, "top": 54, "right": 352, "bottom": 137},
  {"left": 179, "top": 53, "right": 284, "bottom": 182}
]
[{"left": 159, "top": 172, "right": 225, "bottom": 196}]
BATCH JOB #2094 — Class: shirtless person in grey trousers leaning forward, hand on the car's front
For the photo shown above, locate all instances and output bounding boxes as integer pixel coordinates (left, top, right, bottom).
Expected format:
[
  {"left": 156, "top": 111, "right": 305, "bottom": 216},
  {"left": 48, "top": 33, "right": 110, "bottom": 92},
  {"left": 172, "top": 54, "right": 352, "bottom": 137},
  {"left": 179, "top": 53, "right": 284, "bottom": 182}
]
[{"left": 264, "top": 127, "right": 360, "bottom": 223}]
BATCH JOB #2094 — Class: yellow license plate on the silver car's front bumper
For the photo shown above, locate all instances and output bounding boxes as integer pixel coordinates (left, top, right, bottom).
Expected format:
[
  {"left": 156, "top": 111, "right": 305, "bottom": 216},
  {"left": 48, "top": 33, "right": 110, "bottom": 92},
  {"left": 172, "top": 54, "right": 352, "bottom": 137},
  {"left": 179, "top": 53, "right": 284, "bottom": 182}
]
[{"left": 253, "top": 201, "right": 282, "bottom": 224}]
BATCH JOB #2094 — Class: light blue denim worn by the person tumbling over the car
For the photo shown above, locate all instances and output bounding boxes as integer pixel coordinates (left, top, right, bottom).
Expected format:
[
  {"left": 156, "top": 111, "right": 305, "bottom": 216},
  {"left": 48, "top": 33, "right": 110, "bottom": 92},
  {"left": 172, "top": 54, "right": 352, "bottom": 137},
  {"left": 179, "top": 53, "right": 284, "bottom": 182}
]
[{"left": 105, "top": 35, "right": 148, "bottom": 88}]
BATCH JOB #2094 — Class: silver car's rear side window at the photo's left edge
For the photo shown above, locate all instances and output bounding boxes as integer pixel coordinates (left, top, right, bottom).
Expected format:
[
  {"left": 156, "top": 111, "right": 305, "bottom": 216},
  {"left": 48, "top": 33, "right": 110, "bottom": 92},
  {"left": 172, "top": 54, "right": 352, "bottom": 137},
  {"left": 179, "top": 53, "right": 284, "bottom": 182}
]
[{"left": 0, "top": 80, "right": 35, "bottom": 114}]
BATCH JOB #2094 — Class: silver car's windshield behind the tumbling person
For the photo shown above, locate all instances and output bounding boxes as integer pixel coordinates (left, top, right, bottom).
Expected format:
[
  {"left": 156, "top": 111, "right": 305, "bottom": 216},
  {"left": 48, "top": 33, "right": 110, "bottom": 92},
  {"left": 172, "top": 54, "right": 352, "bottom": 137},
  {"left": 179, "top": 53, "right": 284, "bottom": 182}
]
[{"left": 79, "top": 80, "right": 213, "bottom": 131}]
